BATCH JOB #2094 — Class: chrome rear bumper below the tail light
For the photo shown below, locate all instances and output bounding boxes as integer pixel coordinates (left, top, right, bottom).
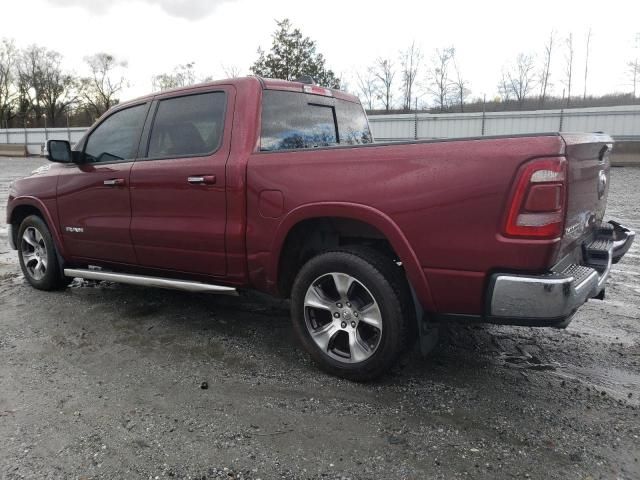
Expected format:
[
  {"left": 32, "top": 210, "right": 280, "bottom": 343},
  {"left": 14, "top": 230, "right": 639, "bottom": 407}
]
[{"left": 486, "top": 222, "right": 635, "bottom": 326}]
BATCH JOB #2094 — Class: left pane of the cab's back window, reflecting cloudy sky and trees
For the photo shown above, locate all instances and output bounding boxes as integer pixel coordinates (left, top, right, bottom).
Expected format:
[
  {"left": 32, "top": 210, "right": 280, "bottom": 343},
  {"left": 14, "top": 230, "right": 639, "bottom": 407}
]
[{"left": 260, "top": 90, "right": 338, "bottom": 151}]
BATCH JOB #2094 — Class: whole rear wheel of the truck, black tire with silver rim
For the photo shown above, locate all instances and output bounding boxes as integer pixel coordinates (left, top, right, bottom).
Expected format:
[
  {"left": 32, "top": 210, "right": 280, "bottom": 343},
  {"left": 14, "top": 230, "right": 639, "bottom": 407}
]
[{"left": 291, "top": 246, "right": 415, "bottom": 381}]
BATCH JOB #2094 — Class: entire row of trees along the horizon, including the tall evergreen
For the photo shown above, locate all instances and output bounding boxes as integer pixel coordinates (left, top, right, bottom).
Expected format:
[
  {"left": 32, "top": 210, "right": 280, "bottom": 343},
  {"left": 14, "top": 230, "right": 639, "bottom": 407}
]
[{"left": 0, "top": 19, "right": 640, "bottom": 127}]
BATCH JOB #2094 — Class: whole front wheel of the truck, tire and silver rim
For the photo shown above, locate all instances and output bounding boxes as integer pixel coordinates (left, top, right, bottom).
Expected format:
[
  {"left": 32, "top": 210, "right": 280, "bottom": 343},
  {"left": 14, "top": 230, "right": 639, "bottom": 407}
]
[{"left": 16, "top": 215, "right": 73, "bottom": 290}]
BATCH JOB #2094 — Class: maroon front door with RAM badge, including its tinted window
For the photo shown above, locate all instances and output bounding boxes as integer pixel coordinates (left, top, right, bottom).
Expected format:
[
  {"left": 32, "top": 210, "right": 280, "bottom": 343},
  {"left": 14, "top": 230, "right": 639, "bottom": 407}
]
[{"left": 57, "top": 103, "right": 149, "bottom": 264}]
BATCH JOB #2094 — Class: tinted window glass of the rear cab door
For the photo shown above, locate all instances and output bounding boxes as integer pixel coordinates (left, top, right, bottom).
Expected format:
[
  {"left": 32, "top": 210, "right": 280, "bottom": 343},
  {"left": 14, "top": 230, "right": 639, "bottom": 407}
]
[{"left": 147, "top": 92, "right": 226, "bottom": 158}]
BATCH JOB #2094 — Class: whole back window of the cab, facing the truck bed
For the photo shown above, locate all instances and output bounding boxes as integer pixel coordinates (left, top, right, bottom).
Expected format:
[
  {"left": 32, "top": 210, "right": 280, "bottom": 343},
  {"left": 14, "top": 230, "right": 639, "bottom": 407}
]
[{"left": 260, "top": 90, "right": 372, "bottom": 151}]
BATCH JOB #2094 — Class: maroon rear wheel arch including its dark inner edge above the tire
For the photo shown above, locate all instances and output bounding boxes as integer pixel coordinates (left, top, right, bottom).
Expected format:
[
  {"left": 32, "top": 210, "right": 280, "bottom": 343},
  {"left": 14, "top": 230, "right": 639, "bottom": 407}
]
[{"left": 267, "top": 202, "right": 434, "bottom": 310}]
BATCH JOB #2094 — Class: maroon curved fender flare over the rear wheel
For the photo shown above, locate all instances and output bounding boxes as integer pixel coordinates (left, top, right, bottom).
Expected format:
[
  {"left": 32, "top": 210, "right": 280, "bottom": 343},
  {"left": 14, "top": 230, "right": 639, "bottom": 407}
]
[{"left": 267, "top": 202, "right": 435, "bottom": 311}]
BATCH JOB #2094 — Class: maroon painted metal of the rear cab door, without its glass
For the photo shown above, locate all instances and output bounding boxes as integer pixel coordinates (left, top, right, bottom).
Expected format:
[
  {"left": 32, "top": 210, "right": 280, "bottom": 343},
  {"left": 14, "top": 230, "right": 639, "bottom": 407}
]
[{"left": 130, "top": 86, "right": 235, "bottom": 277}]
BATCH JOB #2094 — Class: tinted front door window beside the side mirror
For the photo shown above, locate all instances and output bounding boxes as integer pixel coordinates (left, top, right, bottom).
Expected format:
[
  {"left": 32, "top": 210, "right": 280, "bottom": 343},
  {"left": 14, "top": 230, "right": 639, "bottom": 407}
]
[{"left": 84, "top": 104, "right": 147, "bottom": 163}]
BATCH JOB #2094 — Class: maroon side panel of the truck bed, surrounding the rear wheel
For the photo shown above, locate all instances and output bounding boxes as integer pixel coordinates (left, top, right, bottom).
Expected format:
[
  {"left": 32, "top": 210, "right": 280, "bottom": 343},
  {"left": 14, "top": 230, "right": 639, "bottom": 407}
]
[{"left": 247, "top": 135, "right": 564, "bottom": 313}]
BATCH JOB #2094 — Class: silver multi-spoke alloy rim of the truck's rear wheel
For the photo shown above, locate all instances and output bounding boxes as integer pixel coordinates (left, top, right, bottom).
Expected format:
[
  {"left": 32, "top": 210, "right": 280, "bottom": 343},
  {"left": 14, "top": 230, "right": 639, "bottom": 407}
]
[{"left": 304, "top": 272, "right": 382, "bottom": 363}]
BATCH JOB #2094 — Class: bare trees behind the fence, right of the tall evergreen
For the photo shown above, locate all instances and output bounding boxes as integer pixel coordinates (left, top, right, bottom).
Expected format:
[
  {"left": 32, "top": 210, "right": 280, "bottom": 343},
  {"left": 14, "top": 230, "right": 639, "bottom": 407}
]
[{"left": 356, "top": 30, "right": 640, "bottom": 113}]
